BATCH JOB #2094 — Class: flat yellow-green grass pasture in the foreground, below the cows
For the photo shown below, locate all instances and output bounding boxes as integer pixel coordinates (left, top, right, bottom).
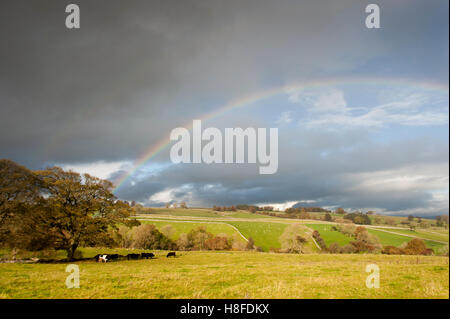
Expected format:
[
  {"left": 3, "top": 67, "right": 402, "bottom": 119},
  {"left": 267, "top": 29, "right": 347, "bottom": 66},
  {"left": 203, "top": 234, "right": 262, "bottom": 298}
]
[{"left": 0, "top": 250, "right": 449, "bottom": 298}]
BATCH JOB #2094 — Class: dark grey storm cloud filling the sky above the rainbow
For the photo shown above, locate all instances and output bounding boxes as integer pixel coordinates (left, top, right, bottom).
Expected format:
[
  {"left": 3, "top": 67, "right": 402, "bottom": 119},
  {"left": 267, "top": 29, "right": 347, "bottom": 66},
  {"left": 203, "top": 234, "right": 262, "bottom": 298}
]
[{"left": 0, "top": 1, "right": 445, "bottom": 166}]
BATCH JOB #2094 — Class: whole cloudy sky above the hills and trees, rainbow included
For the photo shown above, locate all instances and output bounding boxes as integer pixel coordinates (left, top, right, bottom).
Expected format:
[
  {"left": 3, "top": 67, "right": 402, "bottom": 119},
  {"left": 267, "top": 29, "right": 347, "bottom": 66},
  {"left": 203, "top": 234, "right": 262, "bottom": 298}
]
[{"left": 0, "top": 0, "right": 449, "bottom": 216}]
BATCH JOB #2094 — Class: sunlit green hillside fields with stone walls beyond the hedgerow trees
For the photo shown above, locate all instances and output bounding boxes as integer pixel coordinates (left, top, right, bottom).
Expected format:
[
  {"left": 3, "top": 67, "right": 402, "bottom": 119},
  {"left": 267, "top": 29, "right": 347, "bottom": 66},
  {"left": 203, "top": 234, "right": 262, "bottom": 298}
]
[{"left": 135, "top": 208, "right": 449, "bottom": 252}]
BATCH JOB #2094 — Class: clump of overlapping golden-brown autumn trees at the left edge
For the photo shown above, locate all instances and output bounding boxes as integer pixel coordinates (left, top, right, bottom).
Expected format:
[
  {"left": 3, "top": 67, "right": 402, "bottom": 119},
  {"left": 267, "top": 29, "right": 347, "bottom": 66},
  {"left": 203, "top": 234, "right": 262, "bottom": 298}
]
[{"left": 0, "top": 161, "right": 132, "bottom": 259}]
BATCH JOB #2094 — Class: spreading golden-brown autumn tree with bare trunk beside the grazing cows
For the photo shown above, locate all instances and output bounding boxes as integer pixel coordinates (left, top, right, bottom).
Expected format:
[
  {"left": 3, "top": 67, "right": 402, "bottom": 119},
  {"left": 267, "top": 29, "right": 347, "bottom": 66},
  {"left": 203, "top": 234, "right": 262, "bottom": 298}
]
[{"left": 30, "top": 167, "right": 130, "bottom": 259}]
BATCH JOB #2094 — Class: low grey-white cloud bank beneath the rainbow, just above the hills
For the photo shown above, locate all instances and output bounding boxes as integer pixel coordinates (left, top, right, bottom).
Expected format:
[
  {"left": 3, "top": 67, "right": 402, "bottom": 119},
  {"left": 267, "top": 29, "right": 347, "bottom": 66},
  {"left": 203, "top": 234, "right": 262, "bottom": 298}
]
[{"left": 118, "top": 132, "right": 448, "bottom": 213}]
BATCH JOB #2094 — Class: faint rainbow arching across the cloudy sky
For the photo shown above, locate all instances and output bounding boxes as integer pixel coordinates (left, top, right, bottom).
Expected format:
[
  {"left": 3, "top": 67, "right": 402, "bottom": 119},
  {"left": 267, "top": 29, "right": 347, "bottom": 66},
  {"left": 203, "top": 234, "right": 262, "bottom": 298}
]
[{"left": 114, "top": 77, "right": 449, "bottom": 191}]
